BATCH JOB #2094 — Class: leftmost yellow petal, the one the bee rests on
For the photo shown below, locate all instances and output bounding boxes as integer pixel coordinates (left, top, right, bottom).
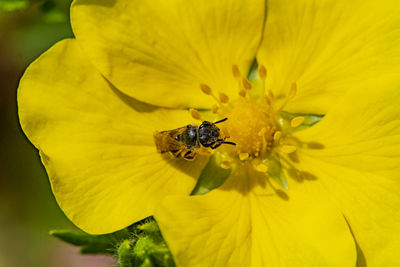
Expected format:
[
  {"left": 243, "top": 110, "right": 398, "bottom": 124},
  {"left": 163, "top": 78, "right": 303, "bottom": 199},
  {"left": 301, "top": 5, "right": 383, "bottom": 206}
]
[{"left": 18, "top": 40, "right": 205, "bottom": 233}]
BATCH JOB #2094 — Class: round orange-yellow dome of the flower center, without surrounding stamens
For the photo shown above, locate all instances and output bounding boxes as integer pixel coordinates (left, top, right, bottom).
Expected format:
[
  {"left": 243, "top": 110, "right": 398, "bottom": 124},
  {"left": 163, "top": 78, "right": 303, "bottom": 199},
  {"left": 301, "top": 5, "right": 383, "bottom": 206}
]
[{"left": 226, "top": 100, "right": 274, "bottom": 156}]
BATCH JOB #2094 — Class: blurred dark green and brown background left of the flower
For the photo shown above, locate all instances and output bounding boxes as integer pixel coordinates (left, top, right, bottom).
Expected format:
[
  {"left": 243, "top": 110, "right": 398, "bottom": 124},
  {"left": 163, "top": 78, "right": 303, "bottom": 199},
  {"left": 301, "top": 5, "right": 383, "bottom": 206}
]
[{"left": 0, "top": 0, "right": 114, "bottom": 267}]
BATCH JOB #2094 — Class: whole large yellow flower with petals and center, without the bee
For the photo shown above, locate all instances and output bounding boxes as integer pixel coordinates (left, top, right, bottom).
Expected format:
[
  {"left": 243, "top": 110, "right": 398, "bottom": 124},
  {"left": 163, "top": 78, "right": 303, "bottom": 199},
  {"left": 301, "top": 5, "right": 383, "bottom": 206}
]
[{"left": 18, "top": 0, "right": 400, "bottom": 266}]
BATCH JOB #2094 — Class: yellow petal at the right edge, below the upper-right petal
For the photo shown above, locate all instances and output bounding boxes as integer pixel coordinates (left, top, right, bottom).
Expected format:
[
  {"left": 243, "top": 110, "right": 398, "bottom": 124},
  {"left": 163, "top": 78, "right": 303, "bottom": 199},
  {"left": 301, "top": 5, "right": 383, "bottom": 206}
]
[{"left": 295, "top": 77, "right": 400, "bottom": 266}]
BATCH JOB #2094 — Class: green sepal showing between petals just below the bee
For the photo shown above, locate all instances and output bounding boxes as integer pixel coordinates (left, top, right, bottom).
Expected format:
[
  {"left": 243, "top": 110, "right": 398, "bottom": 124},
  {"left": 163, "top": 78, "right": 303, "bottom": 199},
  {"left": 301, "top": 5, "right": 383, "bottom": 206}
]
[{"left": 191, "top": 152, "right": 232, "bottom": 195}]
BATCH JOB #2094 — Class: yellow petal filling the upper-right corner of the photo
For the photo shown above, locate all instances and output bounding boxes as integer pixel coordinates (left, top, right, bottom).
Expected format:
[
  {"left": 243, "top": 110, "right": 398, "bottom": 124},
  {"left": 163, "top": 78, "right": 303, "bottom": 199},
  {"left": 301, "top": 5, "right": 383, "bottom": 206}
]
[{"left": 258, "top": 0, "right": 400, "bottom": 114}]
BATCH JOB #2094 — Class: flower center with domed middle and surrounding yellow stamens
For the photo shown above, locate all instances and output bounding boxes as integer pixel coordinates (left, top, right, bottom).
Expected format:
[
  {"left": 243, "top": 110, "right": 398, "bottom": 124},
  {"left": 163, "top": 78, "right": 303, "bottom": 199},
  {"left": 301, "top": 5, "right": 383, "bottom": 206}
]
[{"left": 190, "top": 65, "right": 305, "bottom": 188}]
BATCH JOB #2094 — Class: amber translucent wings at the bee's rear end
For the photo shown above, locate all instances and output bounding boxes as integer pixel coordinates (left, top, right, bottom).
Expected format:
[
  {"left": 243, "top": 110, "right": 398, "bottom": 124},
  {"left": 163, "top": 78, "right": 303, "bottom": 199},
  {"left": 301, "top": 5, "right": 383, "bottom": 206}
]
[{"left": 154, "top": 127, "right": 186, "bottom": 153}]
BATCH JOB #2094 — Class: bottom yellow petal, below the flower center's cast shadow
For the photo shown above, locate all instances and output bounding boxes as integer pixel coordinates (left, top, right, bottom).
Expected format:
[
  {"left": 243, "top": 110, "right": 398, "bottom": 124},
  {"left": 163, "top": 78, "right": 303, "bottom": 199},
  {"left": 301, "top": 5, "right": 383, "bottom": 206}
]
[{"left": 155, "top": 168, "right": 356, "bottom": 266}]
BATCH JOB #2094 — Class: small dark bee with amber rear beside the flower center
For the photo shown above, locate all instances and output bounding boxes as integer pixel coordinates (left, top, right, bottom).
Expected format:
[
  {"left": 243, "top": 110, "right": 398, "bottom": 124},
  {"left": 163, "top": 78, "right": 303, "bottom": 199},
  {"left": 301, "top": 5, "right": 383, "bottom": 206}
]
[{"left": 154, "top": 118, "right": 236, "bottom": 160}]
